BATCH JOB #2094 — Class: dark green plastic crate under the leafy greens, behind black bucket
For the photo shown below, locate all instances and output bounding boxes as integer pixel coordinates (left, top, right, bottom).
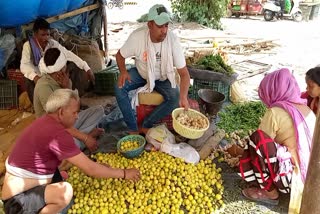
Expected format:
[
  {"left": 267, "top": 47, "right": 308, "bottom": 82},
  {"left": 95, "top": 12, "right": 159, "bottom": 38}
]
[{"left": 191, "top": 79, "right": 230, "bottom": 101}]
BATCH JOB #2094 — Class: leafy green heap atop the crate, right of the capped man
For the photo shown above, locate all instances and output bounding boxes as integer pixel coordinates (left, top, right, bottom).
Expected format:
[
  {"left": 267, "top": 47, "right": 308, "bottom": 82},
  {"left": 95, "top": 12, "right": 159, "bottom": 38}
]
[{"left": 194, "top": 54, "right": 234, "bottom": 76}]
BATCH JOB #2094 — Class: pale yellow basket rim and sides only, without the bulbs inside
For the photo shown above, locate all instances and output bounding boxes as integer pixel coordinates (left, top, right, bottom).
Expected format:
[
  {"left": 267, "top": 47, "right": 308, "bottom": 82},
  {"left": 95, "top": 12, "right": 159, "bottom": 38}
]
[{"left": 172, "top": 108, "right": 210, "bottom": 139}]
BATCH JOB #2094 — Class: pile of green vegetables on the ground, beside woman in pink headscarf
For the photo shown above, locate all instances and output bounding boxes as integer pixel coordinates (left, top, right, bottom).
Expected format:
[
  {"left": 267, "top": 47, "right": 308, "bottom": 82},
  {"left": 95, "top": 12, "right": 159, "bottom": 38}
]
[{"left": 217, "top": 101, "right": 266, "bottom": 135}]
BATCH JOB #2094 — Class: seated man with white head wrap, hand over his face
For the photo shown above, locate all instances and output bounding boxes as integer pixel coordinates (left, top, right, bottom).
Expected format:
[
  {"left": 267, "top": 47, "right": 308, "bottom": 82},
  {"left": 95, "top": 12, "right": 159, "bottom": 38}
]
[{"left": 33, "top": 48, "right": 104, "bottom": 151}]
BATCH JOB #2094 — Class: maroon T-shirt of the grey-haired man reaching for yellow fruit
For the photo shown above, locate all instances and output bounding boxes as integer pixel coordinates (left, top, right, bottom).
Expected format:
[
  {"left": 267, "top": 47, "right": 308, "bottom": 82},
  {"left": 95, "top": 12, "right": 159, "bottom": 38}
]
[{"left": 8, "top": 115, "right": 81, "bottom": 175}]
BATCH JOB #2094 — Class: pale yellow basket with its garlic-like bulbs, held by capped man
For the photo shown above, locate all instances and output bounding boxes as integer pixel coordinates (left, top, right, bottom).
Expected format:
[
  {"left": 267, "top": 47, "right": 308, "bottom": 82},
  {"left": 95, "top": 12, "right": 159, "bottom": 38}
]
[{"left": 172, "top": 108, "right": 210, "bottom": 139}]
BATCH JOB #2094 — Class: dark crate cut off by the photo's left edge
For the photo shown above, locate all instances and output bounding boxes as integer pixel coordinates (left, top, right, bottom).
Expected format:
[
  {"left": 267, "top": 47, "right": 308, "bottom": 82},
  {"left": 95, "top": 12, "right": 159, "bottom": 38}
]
[{"left": 0, "top": 80, "right": 18, "bottom": 110}]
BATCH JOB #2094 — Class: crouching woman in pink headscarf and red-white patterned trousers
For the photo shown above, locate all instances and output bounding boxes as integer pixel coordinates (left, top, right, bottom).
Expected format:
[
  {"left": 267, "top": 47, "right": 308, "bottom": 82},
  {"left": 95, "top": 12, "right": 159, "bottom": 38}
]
[{"left": 239, "top": 68, "right": 316, "bottom": 205}]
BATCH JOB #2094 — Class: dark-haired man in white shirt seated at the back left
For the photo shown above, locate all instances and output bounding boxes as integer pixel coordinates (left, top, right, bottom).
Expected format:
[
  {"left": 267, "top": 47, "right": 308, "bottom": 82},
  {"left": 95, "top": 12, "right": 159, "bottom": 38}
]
[{"left": 20, "top": 18, "right": 94, "bottom": 102}]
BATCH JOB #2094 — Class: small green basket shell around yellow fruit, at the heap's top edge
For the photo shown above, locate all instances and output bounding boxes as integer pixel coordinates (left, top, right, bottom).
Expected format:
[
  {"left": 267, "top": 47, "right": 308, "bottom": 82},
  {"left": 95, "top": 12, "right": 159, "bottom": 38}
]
[{"left": 117, "top": 135, "right": 146, "bottom": 159}]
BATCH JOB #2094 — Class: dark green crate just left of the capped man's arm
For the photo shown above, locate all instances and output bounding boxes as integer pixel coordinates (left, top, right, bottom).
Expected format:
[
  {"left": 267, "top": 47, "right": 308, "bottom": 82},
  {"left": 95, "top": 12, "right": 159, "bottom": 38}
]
[{"left": 94, "top": 65, "right": 119, "bottom": 95}]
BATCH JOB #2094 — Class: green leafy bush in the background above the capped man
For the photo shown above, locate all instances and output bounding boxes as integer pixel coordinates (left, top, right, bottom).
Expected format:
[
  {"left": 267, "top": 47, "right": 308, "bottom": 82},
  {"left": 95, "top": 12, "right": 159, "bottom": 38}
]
[{"left": 171, "top": 0, "right": 227, "bottom": 29}]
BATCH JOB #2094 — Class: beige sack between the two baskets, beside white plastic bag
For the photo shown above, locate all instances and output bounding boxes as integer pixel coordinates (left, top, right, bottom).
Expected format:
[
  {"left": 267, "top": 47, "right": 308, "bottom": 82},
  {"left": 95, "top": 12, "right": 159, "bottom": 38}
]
[{"left": 146, "top": 125, "right": 176, "bottom": 150}]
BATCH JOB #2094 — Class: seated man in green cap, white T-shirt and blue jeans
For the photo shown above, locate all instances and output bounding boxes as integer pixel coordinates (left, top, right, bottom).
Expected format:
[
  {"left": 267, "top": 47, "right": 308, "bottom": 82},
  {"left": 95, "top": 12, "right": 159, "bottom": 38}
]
[{"left": 115, "top": 4, "right": 190, "bottom": 133}]
